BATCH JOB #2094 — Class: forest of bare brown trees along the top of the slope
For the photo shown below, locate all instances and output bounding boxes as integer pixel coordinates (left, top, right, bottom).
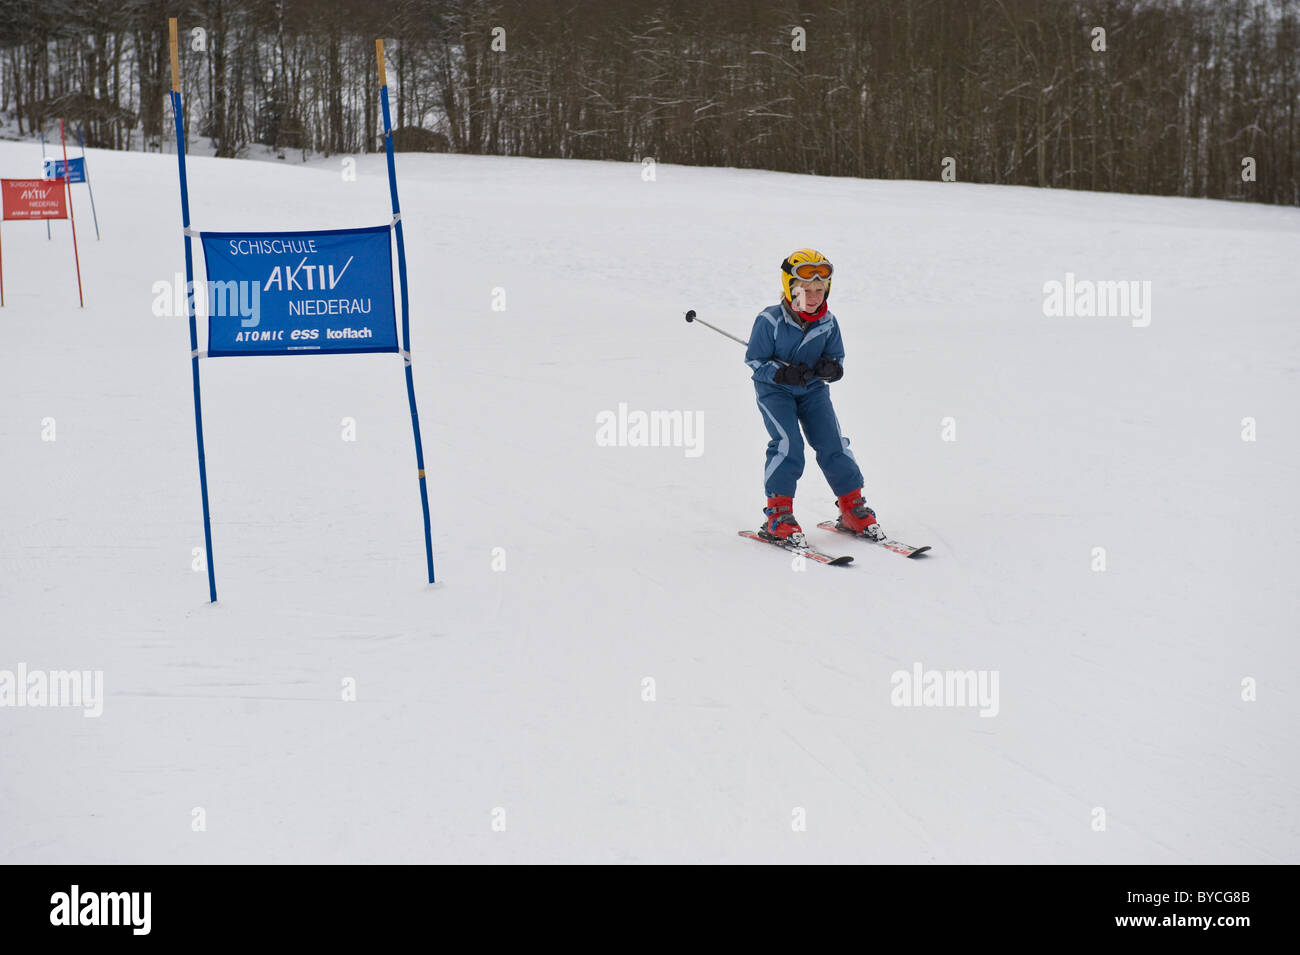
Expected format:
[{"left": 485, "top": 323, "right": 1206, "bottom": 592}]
[{"left": 0, "top": 0, "right": 1300, "bottom": 204}]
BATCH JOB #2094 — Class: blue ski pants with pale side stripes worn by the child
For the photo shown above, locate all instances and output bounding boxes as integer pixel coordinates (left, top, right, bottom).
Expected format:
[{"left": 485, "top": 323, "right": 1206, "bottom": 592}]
[{"left": 754, "top": 383, "right": 862, "bottom": 498}]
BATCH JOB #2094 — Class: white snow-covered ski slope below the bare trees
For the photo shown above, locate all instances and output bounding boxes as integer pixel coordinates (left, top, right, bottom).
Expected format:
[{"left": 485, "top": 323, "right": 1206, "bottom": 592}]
[{"left": 0, "top": 143, "right": 1300, "bottom": 863}]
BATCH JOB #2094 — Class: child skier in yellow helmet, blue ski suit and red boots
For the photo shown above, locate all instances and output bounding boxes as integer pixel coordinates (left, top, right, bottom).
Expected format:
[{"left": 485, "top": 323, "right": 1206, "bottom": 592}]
[{"left": 745, "top": 248, "right": 885, "bottom": 546}]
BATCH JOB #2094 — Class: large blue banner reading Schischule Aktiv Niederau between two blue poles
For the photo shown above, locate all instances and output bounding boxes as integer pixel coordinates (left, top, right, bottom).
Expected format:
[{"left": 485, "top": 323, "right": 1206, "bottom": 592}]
[{"left": 199, "top": 226, "right": 398, "bottom": 357}]
